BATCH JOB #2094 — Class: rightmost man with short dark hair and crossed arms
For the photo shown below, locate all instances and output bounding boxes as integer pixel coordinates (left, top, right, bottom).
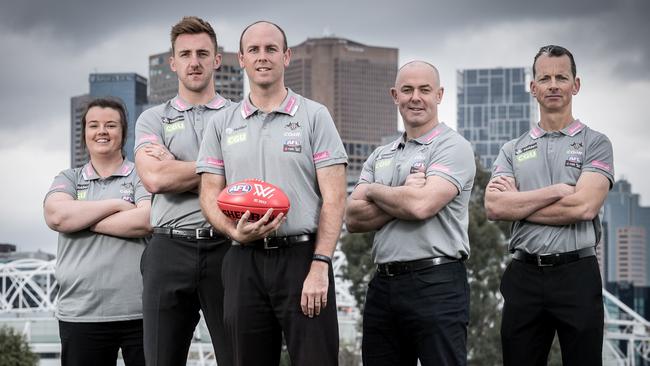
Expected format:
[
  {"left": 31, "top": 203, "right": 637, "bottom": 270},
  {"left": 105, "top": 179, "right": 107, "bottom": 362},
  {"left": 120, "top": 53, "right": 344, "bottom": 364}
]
[{"left": 485, "top": 45, "right": 614, "bottom": 366}]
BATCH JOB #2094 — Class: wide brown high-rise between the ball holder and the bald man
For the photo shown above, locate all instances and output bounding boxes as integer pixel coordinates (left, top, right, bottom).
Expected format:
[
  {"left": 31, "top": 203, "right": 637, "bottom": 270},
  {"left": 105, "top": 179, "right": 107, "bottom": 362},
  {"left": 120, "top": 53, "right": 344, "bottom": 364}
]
[{"left": 284, "top": 37, "right": 398, "bottom": 183}]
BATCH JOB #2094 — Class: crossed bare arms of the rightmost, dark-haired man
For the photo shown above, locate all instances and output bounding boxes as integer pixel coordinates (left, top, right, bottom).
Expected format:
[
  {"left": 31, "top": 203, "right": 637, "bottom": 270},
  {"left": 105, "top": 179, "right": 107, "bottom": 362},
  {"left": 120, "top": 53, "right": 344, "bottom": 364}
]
[{"left": 485, "top": 172, "right": 609, "bottom": 225}]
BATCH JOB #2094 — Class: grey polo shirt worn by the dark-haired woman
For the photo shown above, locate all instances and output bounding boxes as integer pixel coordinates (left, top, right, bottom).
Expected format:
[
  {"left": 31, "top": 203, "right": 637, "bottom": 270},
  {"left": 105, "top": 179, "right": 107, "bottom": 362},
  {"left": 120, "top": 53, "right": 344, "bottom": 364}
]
[{"left": 45, "top": 160, "right": 151, "bottom": 322}]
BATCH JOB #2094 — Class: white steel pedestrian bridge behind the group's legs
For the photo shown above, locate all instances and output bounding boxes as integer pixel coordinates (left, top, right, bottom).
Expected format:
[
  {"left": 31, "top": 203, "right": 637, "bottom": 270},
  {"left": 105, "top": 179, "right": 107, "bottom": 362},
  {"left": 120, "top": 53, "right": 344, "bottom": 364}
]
[{"left": 0, "top": 258, "right": 650, "bottom": 366}]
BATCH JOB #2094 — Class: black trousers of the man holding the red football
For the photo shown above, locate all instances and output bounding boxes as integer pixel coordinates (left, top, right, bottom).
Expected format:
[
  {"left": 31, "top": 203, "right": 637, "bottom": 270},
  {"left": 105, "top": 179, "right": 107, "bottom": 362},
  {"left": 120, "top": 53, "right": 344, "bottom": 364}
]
[{"left": 223, "top": 243, "right": 339, "bottom": 366}]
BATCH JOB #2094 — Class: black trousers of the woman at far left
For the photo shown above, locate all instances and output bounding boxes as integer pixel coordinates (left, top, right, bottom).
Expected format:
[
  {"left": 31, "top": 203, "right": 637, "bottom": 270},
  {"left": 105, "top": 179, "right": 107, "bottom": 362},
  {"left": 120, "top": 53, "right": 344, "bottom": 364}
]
[{"left": 59, "top": 320, "right": 144, "bottom": 366}]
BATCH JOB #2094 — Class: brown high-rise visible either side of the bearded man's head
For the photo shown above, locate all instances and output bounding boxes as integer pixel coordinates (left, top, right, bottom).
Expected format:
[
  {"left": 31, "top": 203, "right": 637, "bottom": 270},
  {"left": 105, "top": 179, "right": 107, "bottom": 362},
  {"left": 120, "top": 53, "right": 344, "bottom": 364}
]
[{"left": 149, "top": 47, "right": 244, "bottom": 105}]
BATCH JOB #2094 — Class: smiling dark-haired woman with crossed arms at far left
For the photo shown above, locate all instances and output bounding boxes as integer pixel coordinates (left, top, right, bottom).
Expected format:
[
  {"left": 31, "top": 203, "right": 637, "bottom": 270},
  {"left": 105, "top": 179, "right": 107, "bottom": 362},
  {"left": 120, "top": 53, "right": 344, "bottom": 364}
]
[{"left": 43, "top": 98, "right": 151, "bottom": 366}]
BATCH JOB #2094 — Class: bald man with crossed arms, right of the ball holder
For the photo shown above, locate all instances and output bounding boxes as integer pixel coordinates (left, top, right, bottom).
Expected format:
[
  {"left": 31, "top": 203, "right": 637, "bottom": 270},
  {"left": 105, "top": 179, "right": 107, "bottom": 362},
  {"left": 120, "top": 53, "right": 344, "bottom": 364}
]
[{"left": 346, "top": 61, "right": 476, "bottom": 366}]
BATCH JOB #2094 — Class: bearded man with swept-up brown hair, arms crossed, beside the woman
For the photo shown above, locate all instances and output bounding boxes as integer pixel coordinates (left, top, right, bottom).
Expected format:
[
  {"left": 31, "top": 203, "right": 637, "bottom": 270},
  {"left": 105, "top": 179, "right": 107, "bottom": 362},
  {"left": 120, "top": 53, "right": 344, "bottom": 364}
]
[{"left": 135, "top": 17, "right": 232, "bottom": 366}]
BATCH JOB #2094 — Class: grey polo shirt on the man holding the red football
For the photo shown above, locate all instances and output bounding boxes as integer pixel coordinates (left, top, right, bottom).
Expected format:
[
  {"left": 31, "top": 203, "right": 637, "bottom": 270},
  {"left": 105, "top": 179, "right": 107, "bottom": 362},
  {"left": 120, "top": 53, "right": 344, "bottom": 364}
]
[{"left": 196, "top": 90, "right": 347, "bottom": 236}]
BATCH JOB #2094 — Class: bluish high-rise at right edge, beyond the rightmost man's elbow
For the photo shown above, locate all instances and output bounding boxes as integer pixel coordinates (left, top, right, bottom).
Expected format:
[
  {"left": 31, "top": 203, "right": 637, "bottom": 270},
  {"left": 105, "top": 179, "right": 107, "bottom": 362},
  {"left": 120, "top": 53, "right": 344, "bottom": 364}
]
[{"left": 603, "top": 179, "right": 650, "bottom": 284}]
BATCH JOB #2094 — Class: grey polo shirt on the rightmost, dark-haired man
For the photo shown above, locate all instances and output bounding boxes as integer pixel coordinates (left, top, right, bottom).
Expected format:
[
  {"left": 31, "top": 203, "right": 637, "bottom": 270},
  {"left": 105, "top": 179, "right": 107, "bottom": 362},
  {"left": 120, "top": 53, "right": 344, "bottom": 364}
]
[{"left": 492, "top": 120, "right": 614, "bottom": 254}]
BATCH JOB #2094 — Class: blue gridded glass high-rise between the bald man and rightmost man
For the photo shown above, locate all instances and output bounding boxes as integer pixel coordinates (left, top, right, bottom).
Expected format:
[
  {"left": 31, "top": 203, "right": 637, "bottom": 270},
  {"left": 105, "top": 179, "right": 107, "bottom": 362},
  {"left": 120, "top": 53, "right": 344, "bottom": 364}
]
[{"left": 457, "top": 67, "right": 537, "bottom": 169}]
